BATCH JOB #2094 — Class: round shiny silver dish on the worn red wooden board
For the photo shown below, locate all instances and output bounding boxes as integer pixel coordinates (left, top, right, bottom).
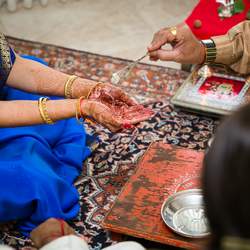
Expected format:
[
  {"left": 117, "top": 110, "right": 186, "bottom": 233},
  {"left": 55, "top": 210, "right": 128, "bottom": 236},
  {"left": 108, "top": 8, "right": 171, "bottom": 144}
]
[{"left": 161, "top": 189, "right": 209, "bottom": 238}]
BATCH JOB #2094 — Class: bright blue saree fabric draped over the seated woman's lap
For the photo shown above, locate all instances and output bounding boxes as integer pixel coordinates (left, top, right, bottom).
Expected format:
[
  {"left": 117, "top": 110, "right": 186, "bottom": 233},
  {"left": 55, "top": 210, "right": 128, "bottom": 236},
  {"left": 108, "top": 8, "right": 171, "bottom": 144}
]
[{"left": 0, "top": 55, "right": 91, "bottom": 236}]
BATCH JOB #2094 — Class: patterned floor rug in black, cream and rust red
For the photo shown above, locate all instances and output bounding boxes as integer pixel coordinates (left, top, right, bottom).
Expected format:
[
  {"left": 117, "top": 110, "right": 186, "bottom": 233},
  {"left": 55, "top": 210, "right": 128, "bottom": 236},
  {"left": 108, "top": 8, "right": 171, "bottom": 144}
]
[{"left": 0, "top": 38, "right": 218, "bottom": 250}]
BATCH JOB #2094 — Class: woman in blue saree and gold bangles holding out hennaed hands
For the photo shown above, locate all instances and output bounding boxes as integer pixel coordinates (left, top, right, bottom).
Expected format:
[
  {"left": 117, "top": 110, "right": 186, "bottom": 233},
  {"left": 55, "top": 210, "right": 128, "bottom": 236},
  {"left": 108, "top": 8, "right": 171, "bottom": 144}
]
[{"left": 0, "top": 33, "right": 139, "bottom": 243}]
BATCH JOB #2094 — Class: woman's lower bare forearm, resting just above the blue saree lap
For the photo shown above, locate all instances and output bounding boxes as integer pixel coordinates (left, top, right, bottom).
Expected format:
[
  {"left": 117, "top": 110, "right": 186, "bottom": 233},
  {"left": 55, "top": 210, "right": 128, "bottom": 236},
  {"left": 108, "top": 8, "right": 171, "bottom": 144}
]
[{"left": 0, "top": 99, "right": 77, "bottom": 127}]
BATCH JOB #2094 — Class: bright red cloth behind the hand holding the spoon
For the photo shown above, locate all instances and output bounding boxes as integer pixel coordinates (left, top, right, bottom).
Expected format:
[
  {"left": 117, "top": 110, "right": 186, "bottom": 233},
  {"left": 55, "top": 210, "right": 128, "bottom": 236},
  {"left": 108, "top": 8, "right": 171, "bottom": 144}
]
[{"left": 185, "top": 0, "right": 250, "bottom": 39}]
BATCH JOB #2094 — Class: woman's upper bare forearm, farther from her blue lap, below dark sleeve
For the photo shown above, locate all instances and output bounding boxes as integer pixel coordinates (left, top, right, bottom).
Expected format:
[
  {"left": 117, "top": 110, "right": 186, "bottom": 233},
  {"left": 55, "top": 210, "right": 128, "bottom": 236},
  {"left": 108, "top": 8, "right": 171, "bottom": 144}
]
[{"left": 7, "top": 55, "right": 95, "bottom": 98}]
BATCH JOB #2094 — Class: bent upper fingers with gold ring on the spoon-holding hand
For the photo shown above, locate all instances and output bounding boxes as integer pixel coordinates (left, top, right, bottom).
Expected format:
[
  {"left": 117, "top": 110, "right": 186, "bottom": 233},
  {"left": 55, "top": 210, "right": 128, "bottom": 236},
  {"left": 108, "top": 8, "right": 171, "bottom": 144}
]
[{"left": 148, "top": 29, "right": 176, "bottom": 52}]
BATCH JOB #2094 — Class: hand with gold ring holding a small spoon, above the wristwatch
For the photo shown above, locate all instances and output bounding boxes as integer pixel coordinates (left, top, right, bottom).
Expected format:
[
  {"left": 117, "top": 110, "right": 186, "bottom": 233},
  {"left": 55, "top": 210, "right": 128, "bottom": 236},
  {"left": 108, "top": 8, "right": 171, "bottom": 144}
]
[{"left": 148, "top": 23, "right": 205, "bottom": 64}]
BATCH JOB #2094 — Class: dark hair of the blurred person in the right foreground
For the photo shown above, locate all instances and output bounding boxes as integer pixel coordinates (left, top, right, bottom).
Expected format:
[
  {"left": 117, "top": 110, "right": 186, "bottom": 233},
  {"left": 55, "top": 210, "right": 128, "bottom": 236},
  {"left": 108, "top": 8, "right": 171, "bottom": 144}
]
[{"left": 202, "top": 102, "right": 250, "bottom": 249}]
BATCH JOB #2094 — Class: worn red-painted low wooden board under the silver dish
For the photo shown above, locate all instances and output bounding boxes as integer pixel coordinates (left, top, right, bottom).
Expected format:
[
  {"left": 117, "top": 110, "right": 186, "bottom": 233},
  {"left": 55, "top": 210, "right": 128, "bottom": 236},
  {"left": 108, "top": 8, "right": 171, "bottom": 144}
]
[{"left": 102, "top": 142, "right": 207, "bottom": 249}]
